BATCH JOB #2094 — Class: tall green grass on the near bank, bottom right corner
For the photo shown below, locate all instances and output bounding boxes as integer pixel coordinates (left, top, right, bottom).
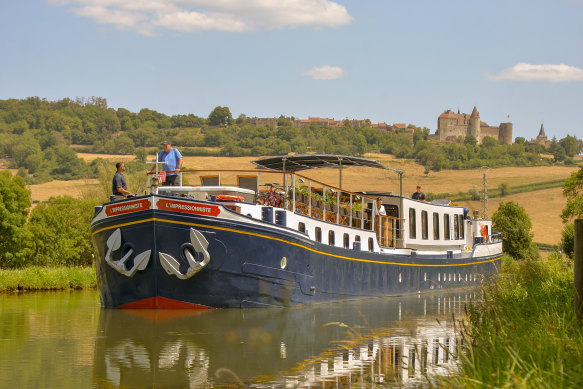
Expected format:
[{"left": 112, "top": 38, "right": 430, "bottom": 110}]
[{"left": 444, "top": 253, "right": 583, "bottom": 388}]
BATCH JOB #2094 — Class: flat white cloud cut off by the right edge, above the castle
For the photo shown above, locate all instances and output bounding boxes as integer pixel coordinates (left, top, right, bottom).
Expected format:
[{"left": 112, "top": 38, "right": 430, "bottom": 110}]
[{"left": 486, "top": 62, "right": 583, "bottom": 82}]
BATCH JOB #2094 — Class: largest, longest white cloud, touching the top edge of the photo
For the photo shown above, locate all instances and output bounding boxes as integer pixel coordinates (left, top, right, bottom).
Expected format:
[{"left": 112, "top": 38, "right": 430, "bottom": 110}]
[{"left": 47, "top": 0, "right": 352, "bottom": 34}]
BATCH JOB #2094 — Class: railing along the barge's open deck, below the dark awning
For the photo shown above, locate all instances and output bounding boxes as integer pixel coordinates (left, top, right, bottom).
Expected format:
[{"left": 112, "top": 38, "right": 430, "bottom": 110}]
[{"left": 148, "top": 169, "right": 404, "bottom": 247}]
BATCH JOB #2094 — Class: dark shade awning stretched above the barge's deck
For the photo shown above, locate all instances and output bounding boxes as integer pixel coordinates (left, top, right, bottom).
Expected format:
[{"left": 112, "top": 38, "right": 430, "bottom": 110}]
[{"left": 252, "top": 154, "right": 404, "bottom": 174}]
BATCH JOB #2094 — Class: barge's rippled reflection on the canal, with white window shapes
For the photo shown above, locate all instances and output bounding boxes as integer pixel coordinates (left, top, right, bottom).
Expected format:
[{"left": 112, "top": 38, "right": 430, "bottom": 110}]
[{"left": 94, "top": 294, "right": 470, "bottom": 388}]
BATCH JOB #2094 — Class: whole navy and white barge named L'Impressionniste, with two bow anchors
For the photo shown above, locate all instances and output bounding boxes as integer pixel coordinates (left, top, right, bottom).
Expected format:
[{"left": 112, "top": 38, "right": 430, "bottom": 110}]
[{"left": 91, "top": 155, "right": 502, "bottom": 308}]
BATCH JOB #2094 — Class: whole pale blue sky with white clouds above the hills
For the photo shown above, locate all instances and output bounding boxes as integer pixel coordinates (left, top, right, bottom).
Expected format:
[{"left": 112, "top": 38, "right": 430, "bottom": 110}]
[{"left": 0, "top": 0, "right": 583, "bottom": 139}]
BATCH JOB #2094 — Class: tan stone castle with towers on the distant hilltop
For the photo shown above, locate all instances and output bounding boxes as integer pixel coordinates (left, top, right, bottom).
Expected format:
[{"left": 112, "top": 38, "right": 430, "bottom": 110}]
[{"left": 430, "top": 106, "right": 512, "bottom": 144}]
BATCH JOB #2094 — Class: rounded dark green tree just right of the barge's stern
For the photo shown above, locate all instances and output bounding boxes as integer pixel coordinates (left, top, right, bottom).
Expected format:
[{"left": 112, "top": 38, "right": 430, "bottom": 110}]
[{"left": 492, "top": 201, "right": 538, "bottom": 259}]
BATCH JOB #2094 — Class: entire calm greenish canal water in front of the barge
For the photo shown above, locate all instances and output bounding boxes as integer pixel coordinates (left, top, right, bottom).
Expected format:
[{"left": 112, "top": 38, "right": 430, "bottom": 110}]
[{"left": 0, "top": 291, "right": 475, "bottom": 389}]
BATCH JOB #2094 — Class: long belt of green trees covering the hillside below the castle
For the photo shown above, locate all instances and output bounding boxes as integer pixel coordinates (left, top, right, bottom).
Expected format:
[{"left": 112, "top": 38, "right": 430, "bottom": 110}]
[{"left": 0, "top": 97, "right": 583, "bottom": 183}]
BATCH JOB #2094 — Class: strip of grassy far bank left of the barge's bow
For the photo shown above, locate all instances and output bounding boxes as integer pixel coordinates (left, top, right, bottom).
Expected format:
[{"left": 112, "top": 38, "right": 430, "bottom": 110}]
[{"left": 0, "top": 267, "right": 97, "bottom": 293}]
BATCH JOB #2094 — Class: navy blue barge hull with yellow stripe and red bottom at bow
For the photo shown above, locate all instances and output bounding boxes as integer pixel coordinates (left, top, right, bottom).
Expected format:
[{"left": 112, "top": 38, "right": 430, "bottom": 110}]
[{"left": 92, "top": 197, "right": 500, "bottom": 308}]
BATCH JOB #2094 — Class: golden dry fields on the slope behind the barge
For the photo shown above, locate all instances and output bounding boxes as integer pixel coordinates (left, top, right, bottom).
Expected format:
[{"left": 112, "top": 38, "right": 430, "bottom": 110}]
[{"left": 20, "top": 153, "right": 578, "bottom": 244}]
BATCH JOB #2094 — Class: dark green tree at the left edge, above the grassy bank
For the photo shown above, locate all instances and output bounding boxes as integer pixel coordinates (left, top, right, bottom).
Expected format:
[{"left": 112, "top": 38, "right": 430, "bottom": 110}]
[{"left": 0, "top": 171, "right": 31, "bottom": 268}]
